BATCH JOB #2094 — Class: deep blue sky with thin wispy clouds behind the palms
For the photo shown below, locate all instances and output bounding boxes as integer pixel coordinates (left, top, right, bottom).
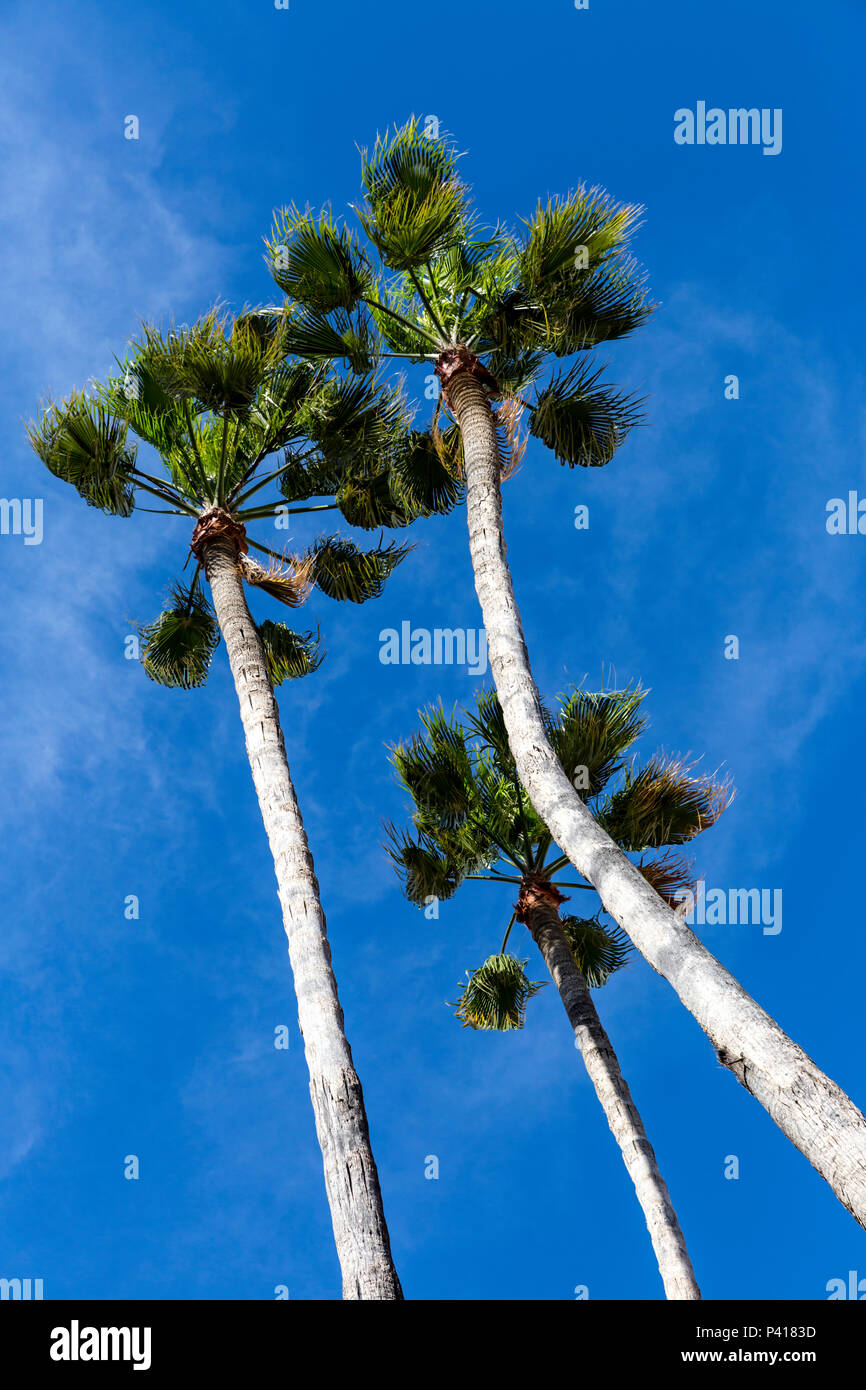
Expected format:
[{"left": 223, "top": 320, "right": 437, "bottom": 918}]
[{"left": 0, "top": 0, "right": 866, "bottom": 1300}]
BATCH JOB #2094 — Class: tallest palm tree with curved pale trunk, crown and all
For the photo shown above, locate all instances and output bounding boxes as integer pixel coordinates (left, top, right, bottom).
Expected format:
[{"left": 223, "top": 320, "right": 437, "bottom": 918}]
[{"left": 268, "top": 120, "right": 866, "bottom": 1225}]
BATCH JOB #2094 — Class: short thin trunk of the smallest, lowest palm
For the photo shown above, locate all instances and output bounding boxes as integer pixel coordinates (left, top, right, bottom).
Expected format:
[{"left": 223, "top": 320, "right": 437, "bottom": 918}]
[{"left": 521, "top": 888, "right": 701, "bottom": 1300}]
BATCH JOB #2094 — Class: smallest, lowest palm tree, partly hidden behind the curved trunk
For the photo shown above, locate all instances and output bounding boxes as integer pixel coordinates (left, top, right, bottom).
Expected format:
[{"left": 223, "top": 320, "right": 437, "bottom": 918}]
[{"left": 388, "top": 687, "right": 728, "bottom": 1300}]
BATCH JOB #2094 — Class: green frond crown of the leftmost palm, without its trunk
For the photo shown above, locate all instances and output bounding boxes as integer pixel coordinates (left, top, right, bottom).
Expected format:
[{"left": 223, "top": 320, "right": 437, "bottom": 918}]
[{"left": 29, "top": 310, "right": 460, "bottom": 688}]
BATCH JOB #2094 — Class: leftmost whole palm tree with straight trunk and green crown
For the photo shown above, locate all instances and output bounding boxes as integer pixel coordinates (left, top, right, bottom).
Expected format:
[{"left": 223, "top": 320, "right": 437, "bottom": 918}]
[{"left": 29, "top": 310, "right": 456, "bottom": 1298}]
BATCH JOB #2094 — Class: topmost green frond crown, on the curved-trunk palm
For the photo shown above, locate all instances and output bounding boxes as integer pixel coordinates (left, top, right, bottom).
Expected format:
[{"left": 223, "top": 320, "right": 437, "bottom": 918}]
[{"left": 267, "top": 118, "right": 652, "bottom": 482}]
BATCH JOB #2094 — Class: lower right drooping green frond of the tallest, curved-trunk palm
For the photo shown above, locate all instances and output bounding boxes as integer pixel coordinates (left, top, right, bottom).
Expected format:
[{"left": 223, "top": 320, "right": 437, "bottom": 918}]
[{"left": 530, "top": 363, "right": 642, "bottom": 468}]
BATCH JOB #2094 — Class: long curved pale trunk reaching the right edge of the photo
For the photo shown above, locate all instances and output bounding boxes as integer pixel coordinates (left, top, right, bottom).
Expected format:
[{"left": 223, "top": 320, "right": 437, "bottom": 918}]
[{"left": 448, "top": 371, "right": 866, "bottom": 1226}]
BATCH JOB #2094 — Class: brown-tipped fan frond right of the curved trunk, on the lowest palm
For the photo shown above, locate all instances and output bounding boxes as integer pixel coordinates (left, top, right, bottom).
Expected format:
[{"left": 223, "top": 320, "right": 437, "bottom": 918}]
[{"left": 596, "top": 755, "right": 733, "bottom": 851}]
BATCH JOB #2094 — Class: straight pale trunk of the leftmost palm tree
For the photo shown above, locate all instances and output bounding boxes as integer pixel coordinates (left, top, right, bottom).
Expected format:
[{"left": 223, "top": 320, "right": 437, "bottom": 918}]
[{"left": 204, "top": 541, "right": 403, "bottom": 1300}]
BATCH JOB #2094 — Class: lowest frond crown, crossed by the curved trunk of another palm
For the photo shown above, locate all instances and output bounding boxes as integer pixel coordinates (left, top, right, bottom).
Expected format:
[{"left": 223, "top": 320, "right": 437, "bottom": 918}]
[{"left": 388, "top": 687, "right": 731, "bottom": 1030}]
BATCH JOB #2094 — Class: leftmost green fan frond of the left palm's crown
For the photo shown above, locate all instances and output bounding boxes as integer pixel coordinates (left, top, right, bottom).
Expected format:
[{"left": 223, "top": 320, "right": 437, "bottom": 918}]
[{"left": 26, "top": 392, "right": 136, "bottom": 517}]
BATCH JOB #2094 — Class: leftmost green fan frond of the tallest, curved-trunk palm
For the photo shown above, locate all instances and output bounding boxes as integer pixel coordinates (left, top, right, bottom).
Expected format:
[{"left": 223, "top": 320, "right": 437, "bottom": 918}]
[{"left": 267, "top": 207, "right": 370, "bottom": 314}]
